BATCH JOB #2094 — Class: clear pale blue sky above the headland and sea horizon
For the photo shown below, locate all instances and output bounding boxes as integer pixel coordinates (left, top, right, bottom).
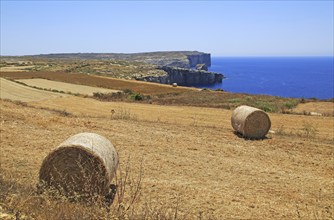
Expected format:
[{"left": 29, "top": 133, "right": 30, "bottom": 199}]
[{"left": 1, "top": 0, "right": 334, "bottom": 56}]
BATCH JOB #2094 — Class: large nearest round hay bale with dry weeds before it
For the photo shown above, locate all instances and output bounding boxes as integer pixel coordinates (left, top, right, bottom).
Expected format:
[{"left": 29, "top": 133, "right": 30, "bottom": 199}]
[{"left": 39, "top": 133, "right": 118, "bottom": 199}]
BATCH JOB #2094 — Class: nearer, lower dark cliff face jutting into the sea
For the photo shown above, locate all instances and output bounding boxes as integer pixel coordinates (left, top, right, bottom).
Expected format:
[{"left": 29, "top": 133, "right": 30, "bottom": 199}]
[{"left": 136, "top": 66, "right": 224, "bottom": 86}]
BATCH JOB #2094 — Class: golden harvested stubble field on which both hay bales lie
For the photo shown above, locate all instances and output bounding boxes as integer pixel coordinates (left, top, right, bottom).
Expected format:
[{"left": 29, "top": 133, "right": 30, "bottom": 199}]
[{"left": 0, "top": 80, "right": 334, "bottom": 219}]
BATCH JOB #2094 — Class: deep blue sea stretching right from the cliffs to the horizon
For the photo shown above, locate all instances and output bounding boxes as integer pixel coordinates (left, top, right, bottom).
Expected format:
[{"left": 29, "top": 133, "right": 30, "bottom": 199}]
[{"left": 201, "top": 57, "right": 334, "bottom": 99}]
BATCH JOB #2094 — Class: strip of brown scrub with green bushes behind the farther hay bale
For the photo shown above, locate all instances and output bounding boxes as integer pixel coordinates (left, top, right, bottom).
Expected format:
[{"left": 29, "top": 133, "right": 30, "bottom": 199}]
[{"left": 93, "top": 89, "right": 300, "bottom": 114}]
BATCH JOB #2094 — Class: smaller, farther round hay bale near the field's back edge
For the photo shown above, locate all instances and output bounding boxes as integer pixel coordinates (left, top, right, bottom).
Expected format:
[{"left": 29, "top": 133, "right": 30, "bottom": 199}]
[{"left": 231, "top": 105, "right": 271, "bottom": 139}]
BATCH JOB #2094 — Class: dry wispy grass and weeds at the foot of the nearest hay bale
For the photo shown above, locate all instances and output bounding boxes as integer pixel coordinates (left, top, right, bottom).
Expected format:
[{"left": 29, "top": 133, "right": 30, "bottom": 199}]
[{"left": 0, "top": 158, "right": 186, "bottom": 220}]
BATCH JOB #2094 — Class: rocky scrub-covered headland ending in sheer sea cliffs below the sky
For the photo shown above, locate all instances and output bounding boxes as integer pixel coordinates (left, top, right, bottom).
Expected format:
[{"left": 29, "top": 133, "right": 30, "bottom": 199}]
[{"left": 0, "top": 51, "right": 224, "bottom": 86}]
